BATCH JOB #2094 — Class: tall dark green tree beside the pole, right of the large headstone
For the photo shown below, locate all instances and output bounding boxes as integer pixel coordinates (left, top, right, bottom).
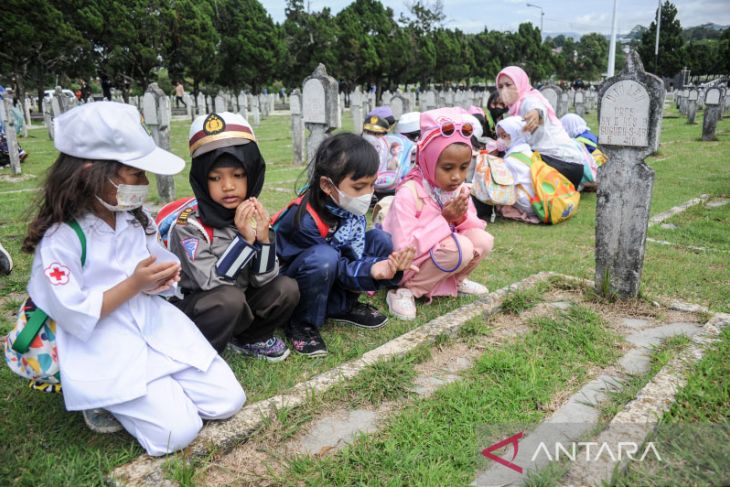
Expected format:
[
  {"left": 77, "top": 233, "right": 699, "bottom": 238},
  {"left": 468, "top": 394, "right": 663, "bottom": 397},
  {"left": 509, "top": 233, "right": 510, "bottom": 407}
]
[{"left": 638, "top": 1, "right": 684, "bottom": 77}]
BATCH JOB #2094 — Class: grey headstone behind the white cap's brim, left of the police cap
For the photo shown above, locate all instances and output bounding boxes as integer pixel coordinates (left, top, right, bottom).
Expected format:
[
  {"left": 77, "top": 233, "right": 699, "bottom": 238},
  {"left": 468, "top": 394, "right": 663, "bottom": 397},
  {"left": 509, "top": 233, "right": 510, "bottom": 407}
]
[{"left": 142, "top": 83, "right": 175, "bottom": 203}]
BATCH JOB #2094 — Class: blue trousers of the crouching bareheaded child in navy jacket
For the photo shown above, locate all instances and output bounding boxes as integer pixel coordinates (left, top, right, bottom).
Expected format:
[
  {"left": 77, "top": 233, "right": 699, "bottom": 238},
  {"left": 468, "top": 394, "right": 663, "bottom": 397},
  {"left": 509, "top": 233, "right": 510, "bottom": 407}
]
[{"left": 281, "top": 229, "right": 393, "bottom": 328}]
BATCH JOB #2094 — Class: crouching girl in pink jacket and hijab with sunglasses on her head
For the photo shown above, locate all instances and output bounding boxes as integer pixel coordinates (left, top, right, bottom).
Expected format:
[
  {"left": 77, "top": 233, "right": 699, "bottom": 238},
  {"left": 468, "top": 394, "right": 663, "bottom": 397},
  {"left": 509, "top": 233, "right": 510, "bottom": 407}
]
[{"left": 383, "top": 108, "right": 494, "bottom": 320}]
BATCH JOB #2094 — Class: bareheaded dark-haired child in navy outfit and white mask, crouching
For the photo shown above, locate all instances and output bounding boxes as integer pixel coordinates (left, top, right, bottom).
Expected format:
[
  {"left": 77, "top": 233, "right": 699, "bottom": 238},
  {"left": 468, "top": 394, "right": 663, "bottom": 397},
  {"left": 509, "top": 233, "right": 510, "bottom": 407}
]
[{"left": 274, "top": 133, "right": 414, "bottom": 357}]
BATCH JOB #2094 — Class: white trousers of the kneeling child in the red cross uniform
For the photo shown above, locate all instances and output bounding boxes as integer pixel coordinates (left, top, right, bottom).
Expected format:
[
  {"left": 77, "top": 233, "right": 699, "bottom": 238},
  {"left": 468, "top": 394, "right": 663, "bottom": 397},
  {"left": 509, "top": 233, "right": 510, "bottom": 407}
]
[{"left": 104, "top": 353, "right": 246, "bottom": 456}]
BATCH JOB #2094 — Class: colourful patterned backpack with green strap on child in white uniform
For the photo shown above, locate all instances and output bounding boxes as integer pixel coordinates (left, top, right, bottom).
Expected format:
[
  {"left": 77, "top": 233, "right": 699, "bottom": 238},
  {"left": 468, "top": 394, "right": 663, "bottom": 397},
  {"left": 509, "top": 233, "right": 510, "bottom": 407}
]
[{"left": 5, "top": 220, "right": 86, "bottom": 392}]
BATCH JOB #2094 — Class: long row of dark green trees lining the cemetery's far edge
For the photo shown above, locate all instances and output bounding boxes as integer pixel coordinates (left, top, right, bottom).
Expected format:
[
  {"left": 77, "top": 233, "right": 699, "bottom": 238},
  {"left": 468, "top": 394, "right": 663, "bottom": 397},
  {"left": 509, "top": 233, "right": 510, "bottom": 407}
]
[{"left": 0, "top": 0, "right": 730, "bottom": 100}]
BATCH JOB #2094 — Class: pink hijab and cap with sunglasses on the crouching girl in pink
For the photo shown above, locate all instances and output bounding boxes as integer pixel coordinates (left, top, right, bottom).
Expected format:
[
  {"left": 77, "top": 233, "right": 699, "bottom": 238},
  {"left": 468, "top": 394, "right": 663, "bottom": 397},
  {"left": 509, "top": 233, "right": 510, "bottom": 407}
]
[{"left": 401, "top": 108, "right": 472, "bottom": 188}]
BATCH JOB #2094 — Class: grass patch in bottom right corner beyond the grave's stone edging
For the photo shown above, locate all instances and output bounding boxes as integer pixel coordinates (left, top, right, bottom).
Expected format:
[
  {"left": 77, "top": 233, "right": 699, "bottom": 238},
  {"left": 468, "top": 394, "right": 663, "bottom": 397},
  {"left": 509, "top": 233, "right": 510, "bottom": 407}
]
[{"left": 613, "top": 328, "right": 730, "bottom": 486}]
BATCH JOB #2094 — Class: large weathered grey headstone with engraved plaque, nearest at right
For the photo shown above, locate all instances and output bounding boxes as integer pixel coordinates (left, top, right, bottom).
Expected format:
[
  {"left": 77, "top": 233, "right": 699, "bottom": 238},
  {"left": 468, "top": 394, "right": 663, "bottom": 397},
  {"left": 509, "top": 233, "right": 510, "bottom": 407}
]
[{"left": 595, "top": 51, "right": 664, "bottom": 298}]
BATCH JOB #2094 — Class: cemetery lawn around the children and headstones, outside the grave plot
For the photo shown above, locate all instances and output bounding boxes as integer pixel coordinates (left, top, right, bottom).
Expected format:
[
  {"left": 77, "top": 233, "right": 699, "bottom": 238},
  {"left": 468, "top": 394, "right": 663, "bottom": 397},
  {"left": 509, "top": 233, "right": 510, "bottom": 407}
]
[{"left": 0, "top": 105, "right": 730, "bottom": 486}]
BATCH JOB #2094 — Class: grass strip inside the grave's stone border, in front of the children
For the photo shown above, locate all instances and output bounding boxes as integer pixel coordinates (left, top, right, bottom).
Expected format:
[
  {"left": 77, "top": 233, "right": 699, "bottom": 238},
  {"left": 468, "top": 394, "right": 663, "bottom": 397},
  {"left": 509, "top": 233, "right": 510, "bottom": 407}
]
[{"left": 275, "top": 306, "right": 619, "bottom": 486}]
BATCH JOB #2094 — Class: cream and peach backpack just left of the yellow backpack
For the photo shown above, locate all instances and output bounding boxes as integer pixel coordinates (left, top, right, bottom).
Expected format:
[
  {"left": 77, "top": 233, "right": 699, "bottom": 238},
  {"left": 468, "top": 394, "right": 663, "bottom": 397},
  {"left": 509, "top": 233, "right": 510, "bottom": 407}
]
[{"left": 471, "top": 151, "right": 517, "bottom": 206}]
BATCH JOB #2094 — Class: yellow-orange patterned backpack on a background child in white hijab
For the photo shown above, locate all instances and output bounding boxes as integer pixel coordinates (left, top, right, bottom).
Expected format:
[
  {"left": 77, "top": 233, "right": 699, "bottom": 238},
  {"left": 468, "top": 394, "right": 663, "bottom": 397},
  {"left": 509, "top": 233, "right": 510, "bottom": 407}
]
[{"left": 512, "top": 152, "right": 580, "bottom": 225}]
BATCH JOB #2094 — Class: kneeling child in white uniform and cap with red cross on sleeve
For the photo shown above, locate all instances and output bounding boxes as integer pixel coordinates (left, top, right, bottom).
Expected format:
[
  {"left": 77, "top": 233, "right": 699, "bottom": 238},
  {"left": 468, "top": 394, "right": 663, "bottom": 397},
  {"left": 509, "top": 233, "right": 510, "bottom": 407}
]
[{"left": 23, "top": 102, "right": 245, "bottom": 456}]
